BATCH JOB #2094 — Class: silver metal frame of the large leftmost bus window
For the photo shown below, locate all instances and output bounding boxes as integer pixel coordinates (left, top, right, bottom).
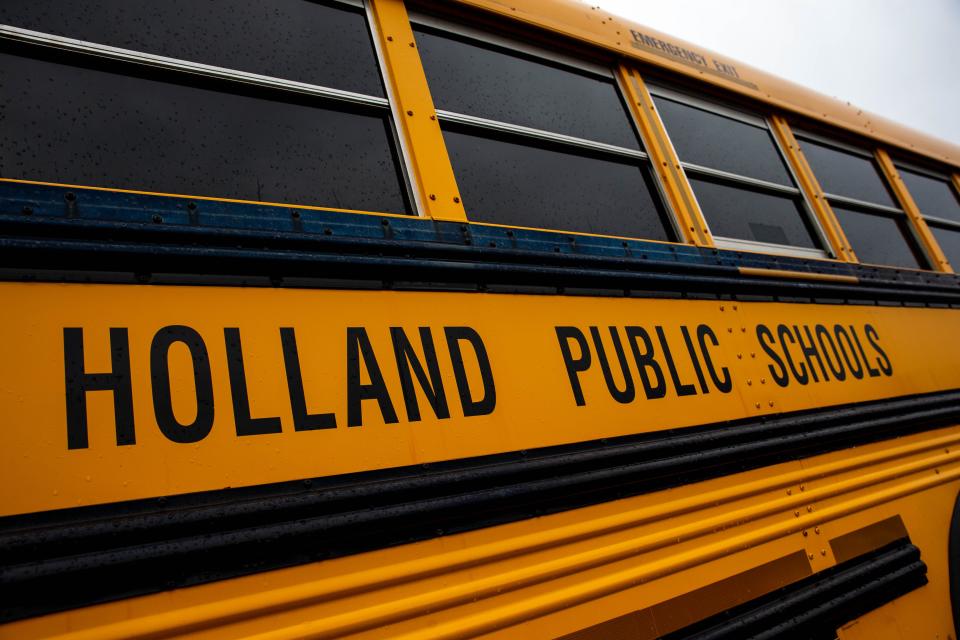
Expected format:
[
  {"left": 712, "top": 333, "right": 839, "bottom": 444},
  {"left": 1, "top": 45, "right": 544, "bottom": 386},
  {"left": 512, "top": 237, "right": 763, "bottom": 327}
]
[{"left": 0, "top": 0, "right": 423, "bottom": 217}]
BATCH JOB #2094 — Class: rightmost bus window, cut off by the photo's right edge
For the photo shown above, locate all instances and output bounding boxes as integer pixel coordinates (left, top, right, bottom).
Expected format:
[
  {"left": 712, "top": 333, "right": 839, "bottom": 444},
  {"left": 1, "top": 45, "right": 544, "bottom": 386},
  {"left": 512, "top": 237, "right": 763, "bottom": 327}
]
[{"left": 897, "top": 164, "right": 960, "bottom": 267}]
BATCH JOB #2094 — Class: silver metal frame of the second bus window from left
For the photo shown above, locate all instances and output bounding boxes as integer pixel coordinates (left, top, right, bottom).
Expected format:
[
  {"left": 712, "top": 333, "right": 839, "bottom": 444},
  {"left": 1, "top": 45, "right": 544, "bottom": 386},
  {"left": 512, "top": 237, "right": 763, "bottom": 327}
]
[{"left": 409, "top": 9, "right": 684, "bottom": 244}]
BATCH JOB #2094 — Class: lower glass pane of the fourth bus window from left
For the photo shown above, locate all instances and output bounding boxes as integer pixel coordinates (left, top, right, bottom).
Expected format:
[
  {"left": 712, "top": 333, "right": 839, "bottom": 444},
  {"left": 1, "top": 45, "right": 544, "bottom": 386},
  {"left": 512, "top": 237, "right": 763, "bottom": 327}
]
[{"left": 833, "top": 205, "right": 927, "bottom": 269}]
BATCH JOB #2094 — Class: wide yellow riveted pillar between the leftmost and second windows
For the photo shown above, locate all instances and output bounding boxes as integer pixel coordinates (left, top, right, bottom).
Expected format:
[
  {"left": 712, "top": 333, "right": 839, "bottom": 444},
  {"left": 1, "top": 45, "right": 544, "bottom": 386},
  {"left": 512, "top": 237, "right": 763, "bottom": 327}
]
[{"left": 369, "top": 0, "right": 467, "bottom": 220}]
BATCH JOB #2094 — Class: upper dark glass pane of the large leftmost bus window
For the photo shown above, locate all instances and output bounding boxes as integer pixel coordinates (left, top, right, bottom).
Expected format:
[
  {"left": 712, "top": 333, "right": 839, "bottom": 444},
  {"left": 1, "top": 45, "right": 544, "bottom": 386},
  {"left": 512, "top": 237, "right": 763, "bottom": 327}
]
[{"left": 0, "top": 0, "right": 384, "bottom": 97}]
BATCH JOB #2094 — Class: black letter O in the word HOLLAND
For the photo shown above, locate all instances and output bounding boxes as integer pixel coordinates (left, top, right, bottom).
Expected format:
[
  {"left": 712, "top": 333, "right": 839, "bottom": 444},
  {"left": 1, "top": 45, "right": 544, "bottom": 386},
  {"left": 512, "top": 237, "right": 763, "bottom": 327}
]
[{"left": 150, "top": 325, "right": 213, "bottom": 444}]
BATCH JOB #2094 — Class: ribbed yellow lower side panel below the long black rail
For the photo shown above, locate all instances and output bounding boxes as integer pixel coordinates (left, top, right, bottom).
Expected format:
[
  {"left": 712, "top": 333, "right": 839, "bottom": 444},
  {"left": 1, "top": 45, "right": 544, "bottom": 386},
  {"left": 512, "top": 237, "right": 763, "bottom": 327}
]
[{"left": 0, "top": 427, "right": 960, "bottom": 640}]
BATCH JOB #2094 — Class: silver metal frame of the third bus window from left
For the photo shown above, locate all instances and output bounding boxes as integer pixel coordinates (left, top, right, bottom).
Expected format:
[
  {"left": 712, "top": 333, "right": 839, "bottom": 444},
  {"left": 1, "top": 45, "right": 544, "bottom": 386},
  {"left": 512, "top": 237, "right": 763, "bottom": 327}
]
[{"left": 647, "top": 82, "right": 837, "bottom": 259}]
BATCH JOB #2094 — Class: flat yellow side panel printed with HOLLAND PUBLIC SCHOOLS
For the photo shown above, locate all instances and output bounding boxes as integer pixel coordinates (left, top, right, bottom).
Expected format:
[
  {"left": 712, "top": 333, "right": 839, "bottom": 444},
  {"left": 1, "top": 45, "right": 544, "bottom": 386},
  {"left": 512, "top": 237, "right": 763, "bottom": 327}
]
[{"left": 0, "top": 283, "right": 960, "bottom": 515}]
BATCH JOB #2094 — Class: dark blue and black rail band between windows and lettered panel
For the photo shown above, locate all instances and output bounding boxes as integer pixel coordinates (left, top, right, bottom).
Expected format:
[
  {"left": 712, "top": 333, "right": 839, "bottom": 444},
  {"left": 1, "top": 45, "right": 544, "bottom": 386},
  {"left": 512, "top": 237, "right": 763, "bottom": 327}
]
[{"left": 0, "top": 183, "right": 960, "bottom": 305}]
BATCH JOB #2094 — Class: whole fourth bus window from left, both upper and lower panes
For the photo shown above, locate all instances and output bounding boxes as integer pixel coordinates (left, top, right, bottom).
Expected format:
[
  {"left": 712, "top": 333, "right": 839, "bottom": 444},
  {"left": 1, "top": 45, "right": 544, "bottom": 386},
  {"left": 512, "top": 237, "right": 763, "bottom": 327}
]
[{"left": 797, "top": 133, "right": 927, "bottom": 269}]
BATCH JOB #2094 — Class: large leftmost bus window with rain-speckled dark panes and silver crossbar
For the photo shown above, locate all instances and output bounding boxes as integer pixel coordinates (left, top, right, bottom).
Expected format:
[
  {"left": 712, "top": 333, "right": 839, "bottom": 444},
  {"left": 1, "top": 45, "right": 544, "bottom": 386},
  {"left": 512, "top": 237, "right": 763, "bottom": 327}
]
[{"left": 0, "top": 0, "right": 410, "bottom": 213}]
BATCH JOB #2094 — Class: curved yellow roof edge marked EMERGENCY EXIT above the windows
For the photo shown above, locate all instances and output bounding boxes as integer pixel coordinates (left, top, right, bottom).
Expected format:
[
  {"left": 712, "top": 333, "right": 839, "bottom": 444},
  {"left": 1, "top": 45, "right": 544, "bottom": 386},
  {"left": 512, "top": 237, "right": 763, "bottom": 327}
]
[{"left": 457, "top": 0, "right": 960, "bottom": 166}]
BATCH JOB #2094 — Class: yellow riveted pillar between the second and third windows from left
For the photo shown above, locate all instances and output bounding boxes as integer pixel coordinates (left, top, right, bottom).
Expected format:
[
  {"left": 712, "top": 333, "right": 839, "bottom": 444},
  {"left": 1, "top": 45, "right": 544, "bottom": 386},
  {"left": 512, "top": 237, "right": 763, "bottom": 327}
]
[{"left": 617, "top": 66, "right": 714, "bottom": 247}]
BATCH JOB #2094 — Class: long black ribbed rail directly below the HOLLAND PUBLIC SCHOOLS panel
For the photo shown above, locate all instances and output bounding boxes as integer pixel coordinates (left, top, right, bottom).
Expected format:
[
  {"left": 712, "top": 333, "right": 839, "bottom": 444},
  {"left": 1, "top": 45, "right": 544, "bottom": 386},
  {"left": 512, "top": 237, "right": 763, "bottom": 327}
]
[{"left": 0, "top": 390, "right": 960, "bottom": 620}]
